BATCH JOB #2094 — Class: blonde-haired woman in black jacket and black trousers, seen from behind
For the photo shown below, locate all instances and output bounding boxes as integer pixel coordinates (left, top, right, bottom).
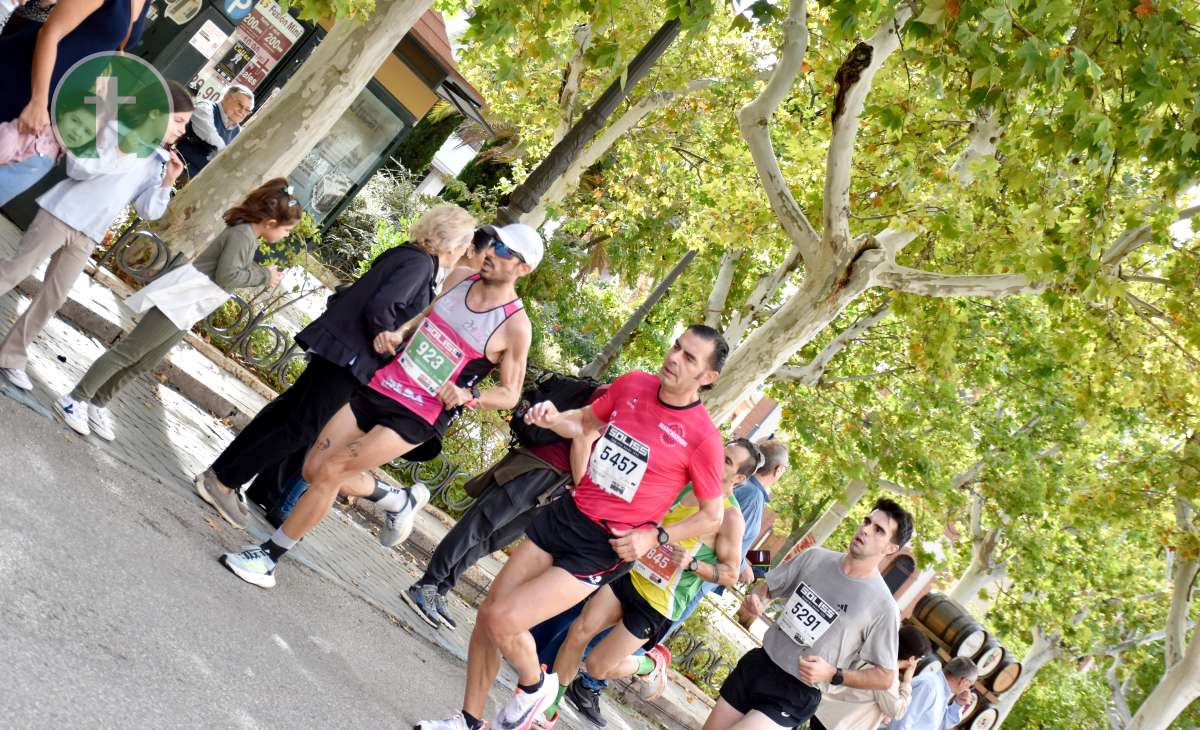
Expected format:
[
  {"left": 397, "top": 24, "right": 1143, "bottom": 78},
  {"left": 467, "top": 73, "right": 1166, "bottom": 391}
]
[{"left": 196, "top": 203, "right": 475, "bottom": 527}]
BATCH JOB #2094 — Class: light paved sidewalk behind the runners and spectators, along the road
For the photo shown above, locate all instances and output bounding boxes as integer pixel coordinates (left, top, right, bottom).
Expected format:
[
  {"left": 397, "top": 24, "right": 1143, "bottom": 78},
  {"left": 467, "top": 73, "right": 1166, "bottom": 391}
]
[{"left": 0, "top": 219, "right": 710, "bottom": 729}]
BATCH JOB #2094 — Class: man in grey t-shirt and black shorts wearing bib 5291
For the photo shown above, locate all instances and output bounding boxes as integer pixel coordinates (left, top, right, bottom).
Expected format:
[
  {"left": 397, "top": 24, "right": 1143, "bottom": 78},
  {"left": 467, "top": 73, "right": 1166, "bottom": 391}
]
[{"left": 703, "top": 499, "right": 912, "bottom": 730}]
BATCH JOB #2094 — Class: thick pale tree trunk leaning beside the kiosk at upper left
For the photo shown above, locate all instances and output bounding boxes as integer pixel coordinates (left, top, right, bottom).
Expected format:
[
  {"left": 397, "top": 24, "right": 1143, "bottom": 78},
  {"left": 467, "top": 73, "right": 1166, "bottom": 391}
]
[{"left": 154, "top": 0, "right": 431, "bottom": 253}]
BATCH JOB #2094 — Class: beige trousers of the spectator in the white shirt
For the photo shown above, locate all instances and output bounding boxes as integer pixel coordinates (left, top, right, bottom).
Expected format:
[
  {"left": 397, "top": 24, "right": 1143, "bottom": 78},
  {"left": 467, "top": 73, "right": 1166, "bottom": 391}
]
[{"left": 0, "top": 210, "right": 96, "bottom": 369}]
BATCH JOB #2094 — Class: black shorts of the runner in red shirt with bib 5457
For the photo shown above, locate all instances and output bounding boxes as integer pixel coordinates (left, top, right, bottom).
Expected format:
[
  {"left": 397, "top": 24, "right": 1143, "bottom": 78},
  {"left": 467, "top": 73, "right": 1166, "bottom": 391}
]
[{"left": 526, "top": 496, "right": 634, "bottom": 588}]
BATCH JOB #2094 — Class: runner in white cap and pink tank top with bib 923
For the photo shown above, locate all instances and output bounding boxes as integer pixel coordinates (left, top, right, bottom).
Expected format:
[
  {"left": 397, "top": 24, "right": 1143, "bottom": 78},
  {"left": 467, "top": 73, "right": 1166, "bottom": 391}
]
[{"left": 221, "top": 223, "right": 542, "bottom": 588}]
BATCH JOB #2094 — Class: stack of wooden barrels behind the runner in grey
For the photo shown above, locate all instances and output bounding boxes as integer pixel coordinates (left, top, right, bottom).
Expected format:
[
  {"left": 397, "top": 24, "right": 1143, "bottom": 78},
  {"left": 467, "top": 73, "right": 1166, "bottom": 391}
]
[{"left": 911, "top": 593, "right": 1021, "bottom": 730}]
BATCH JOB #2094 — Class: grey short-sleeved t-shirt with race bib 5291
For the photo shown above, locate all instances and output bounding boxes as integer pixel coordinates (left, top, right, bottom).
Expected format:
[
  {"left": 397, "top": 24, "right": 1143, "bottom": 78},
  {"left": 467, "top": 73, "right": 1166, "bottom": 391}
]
[{"left": 762, "top": 548, "right": 900, "bottom": 680}]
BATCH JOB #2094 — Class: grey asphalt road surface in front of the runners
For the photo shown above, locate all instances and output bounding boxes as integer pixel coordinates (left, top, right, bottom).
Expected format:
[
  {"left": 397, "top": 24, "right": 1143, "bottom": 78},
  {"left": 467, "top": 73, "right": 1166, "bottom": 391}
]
[{"left": 0, "top": 397, "right": 516, "bottom": 728}]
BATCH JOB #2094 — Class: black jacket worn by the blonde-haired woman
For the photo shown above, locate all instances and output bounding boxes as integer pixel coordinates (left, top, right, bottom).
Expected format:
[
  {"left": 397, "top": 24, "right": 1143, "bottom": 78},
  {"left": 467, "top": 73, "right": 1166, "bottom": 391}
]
[{"left": 295, "top": 244, "right": 438, "bottom": 383}]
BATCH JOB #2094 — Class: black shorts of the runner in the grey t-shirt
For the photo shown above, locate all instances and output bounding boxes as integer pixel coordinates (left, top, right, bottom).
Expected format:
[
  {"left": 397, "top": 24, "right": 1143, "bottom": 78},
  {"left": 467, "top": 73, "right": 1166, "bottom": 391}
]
[{"left": 721, "top": 647, "right": 821, "bottom": 728}]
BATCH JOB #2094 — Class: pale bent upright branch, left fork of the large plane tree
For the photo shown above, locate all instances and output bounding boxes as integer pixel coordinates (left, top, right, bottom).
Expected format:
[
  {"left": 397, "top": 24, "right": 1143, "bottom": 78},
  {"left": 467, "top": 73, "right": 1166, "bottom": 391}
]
[{"left": 738, "top": 0, "right": 821, "bottom": 267}]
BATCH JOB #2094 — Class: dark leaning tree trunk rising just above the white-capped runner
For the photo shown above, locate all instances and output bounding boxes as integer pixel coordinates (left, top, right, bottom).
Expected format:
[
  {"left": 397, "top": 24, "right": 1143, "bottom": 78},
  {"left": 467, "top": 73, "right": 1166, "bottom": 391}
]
[{"left": 496, "top": 19, "right": 679, "bottom": 226}]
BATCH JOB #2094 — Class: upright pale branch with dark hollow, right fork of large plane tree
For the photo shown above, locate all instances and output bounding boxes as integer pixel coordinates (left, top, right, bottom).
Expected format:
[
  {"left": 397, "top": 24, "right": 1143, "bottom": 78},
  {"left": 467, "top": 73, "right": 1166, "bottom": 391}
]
[{"left": 821, "top": 2, "right": 912, "bottom": 251}]
